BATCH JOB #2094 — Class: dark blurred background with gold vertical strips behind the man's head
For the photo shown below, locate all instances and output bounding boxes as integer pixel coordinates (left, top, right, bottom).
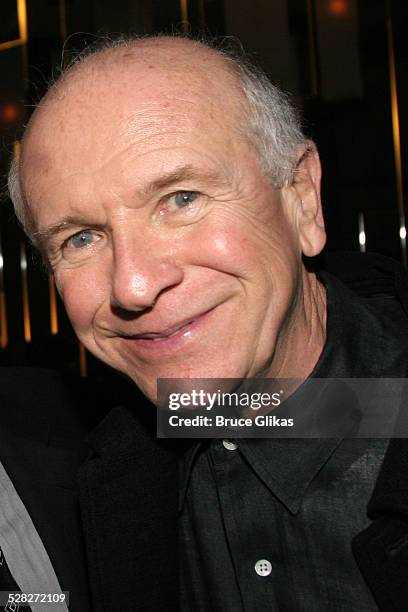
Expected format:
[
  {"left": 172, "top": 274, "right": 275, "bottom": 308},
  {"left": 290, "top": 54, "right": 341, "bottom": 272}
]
[{"left": 0, "top": 0, "right": 408, "bottom": 375}]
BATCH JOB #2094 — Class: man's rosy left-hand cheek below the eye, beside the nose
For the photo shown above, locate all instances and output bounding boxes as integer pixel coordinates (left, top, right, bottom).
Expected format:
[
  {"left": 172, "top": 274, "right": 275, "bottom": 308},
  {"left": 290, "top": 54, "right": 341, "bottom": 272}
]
[{"left": 55, "top": 269, "right": 107, "bottom": 333}]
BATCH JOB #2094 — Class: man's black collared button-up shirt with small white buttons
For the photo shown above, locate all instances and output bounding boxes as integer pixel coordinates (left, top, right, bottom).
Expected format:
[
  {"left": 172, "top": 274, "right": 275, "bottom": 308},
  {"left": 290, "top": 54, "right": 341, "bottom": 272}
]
[{"left": 180, "top": 275, "right": 406, "bottom": 612}]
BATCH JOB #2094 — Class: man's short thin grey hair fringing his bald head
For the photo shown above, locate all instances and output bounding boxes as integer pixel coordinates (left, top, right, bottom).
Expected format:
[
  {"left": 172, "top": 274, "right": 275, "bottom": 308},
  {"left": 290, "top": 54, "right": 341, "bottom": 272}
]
[{"left": 8, "top": 35, "right": 306, "bottom": 233}]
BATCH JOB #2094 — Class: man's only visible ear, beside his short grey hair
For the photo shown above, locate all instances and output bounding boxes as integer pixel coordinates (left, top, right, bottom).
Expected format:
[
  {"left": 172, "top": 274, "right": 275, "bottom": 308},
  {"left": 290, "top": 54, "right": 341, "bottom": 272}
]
[{"left": 292, "top": 140, "right": 326, "bottom": 257}]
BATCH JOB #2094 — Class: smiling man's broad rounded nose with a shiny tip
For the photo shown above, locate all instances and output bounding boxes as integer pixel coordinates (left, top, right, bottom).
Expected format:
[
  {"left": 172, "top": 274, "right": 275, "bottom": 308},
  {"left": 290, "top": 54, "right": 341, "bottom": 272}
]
[{"left": 111, "top": 233, "right": 183, "bottom": 312}]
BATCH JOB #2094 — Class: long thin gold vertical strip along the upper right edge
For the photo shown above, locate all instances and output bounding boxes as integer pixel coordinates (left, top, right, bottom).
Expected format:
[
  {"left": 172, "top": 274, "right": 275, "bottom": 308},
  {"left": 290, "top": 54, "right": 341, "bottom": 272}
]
[{"left": 386, "top": 0, "right": 407, "bottom": 266}]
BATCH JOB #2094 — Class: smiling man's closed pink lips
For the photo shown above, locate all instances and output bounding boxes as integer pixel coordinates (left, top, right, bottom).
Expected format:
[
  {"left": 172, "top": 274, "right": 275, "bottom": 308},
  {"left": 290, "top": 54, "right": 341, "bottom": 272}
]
[{"left": 120, "top": 308, "right": 214, "bottom": 352}]
